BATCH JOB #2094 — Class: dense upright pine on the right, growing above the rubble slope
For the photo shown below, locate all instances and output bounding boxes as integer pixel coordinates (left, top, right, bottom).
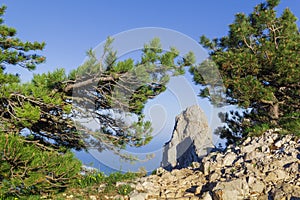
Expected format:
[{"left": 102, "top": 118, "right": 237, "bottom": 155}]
[{"left": 191, "top": 0, "right": 300, "bottom": 143}]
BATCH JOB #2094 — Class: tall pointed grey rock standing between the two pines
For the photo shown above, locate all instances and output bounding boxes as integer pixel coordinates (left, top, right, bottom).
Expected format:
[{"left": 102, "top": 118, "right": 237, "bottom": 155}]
[{"left": 161, "top": 105, "right": 214, "bottom": 169}]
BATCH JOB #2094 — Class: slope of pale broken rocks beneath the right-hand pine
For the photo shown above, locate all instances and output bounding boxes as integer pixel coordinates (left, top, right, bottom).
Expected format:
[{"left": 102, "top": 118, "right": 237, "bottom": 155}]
[{"left": 118, "top": 130, "right": 300, "bottom": 200}]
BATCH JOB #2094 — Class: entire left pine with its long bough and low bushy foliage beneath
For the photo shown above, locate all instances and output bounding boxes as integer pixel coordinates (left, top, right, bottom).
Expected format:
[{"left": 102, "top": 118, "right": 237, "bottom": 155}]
[{"left": 0, "top": 6, "right": 195, "bottom": 199}]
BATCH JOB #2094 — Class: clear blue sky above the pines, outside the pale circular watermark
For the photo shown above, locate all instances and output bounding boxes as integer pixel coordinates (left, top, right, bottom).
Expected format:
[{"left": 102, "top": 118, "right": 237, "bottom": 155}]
[{"left": 1, "top": 0, "right": 300, "bottom": 80}]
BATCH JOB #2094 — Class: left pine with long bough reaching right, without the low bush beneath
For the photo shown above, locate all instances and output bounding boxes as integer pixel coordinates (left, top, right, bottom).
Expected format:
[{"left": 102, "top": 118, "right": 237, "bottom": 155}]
[{"left": 0, "top": 2, "right": 195, "bottom": 151}]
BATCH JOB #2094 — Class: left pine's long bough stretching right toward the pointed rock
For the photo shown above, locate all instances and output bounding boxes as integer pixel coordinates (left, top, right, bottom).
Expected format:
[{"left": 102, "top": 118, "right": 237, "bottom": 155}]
[{"left": 69, "top": 38, "right": 195, "bottom": 148}]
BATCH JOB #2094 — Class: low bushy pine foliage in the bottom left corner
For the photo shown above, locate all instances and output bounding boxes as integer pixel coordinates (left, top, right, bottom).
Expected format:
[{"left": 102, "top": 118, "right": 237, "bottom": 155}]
[{"left": 0, "top": 133, "right": 81, "bottom": 198}]
